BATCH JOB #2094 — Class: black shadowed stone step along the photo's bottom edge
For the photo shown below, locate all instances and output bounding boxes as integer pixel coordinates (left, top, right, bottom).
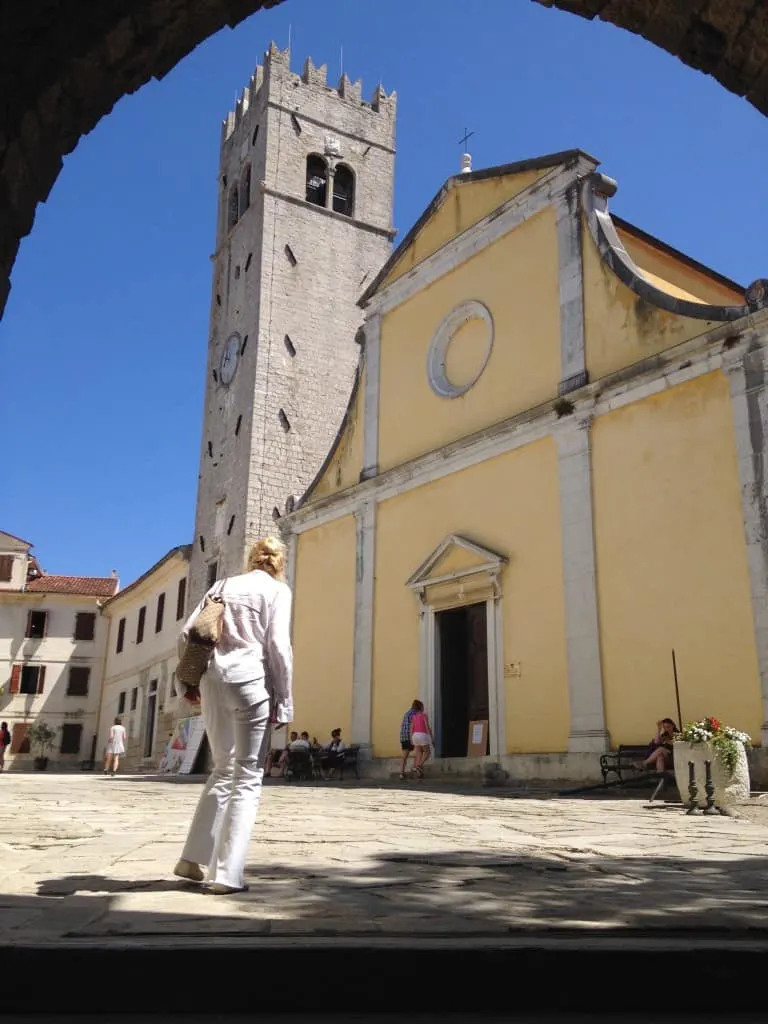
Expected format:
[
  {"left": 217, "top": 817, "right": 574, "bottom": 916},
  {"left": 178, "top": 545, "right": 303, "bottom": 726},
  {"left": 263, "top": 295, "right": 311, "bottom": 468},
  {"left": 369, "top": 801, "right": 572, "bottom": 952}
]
[{"left": 0, "top": 931, "right": 768, "bottom": 1021}]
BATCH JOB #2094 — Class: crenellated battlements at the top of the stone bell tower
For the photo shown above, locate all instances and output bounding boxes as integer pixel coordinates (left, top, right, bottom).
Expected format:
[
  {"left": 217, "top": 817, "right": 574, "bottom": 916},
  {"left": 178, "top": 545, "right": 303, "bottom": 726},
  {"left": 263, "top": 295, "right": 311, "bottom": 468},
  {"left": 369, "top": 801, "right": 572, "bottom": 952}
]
[{"left": 221, "top": 42, "right": 397, "bottom": 143}]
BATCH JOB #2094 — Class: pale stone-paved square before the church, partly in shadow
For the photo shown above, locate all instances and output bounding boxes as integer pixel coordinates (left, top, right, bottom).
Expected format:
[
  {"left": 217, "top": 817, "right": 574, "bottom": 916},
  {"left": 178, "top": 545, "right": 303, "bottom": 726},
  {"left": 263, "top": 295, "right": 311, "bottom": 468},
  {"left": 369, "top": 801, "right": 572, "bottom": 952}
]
[{"left": 0, "top": 773, "right": 768, "bottom": 945}]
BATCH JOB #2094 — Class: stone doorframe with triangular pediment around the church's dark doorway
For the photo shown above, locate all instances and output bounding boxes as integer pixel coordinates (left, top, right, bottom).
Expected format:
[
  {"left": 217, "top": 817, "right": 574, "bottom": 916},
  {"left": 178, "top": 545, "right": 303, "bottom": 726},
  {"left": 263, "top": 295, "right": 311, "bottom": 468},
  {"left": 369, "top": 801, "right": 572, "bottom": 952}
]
[{"left": 407, "top": 534, "right": 509, "bottom": 758}]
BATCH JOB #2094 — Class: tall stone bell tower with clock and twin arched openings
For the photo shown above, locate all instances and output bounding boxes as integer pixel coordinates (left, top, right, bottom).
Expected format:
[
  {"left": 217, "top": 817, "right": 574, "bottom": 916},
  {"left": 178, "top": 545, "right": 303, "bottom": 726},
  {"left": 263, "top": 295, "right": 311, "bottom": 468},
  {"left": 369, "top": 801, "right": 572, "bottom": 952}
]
[{"left": 188, "top": 43, "right": 396, "bottom": 602}]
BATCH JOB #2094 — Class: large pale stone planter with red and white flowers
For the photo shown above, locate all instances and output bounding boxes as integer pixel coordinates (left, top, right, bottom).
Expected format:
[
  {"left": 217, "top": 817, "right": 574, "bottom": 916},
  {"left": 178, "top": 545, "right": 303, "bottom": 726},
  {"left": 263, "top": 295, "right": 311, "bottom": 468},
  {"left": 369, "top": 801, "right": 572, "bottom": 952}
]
[{"left": 674, "top": 718, "right": 752, "bottom": 807}]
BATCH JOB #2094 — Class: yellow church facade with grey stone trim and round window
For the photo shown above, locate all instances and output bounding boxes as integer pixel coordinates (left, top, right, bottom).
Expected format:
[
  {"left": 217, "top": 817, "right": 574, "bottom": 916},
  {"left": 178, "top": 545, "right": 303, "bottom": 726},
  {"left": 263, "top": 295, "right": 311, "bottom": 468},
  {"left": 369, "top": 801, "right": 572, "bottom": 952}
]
[{"left": 281, "top": 151, "right": 768, "bottom": 778}]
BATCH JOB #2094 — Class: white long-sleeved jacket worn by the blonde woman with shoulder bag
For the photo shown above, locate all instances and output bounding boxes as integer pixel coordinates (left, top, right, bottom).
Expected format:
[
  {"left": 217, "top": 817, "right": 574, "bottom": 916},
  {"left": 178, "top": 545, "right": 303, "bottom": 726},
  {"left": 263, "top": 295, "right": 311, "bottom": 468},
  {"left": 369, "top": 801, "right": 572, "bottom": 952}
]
[{"left": 178, "top": 569, "right": 293, "bottom": 723}]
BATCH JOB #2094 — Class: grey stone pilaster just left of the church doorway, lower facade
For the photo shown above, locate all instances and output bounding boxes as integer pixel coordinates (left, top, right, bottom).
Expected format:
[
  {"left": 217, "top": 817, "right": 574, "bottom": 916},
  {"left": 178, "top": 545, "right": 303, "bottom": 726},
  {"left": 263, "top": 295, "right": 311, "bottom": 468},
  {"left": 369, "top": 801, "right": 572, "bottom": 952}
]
[{"left": 352, "top": 501, "right": 376, "bottom": 748}]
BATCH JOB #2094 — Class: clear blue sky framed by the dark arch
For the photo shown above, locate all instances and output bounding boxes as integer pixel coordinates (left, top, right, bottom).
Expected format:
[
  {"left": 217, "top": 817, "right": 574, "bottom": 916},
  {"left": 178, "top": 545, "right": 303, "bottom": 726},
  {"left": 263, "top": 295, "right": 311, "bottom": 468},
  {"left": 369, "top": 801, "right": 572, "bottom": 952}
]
[{"left": 0, "top": 0, "right": 768, "bottom": 585}]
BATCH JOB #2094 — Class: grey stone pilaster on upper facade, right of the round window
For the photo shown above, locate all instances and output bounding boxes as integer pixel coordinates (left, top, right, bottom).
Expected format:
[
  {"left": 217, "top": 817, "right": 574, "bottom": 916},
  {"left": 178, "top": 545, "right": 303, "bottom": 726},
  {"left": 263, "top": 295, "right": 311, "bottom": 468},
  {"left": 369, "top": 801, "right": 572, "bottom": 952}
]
[{"left": 557, "top": 182, "right": 587, "bottom": 394}]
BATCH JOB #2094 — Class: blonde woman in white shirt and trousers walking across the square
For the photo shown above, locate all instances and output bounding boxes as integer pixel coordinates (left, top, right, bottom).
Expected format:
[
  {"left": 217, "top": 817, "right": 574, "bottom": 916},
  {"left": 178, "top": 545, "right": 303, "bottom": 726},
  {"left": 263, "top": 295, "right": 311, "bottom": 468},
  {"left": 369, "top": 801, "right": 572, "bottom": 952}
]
[{"left": 174, "top": 538, "right": 293, "bottom": 895}]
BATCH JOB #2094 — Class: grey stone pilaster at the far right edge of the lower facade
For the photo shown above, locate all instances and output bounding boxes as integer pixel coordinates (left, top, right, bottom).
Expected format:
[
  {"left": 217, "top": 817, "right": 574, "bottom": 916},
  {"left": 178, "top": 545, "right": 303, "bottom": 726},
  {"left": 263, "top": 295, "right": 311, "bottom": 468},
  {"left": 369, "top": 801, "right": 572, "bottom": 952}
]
[{"left": 723, "top": 333, "right": 768, "bottom": 746}]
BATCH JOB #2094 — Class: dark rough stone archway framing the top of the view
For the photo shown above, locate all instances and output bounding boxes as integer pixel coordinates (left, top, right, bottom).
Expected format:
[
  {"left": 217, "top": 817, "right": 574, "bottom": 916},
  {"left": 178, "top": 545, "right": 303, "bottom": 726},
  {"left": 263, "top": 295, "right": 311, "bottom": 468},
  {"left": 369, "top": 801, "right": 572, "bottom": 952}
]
[{"left": 0, "top": 0, "right": 768, "bottom": 312}]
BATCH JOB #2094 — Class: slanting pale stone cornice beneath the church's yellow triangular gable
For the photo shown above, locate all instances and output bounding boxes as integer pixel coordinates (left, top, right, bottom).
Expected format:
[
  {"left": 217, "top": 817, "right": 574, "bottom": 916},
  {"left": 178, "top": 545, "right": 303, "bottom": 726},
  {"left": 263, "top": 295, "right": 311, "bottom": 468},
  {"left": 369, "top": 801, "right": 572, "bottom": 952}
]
[{"left": 366, "top": 158, "right": 596, "bottom": 314}]
